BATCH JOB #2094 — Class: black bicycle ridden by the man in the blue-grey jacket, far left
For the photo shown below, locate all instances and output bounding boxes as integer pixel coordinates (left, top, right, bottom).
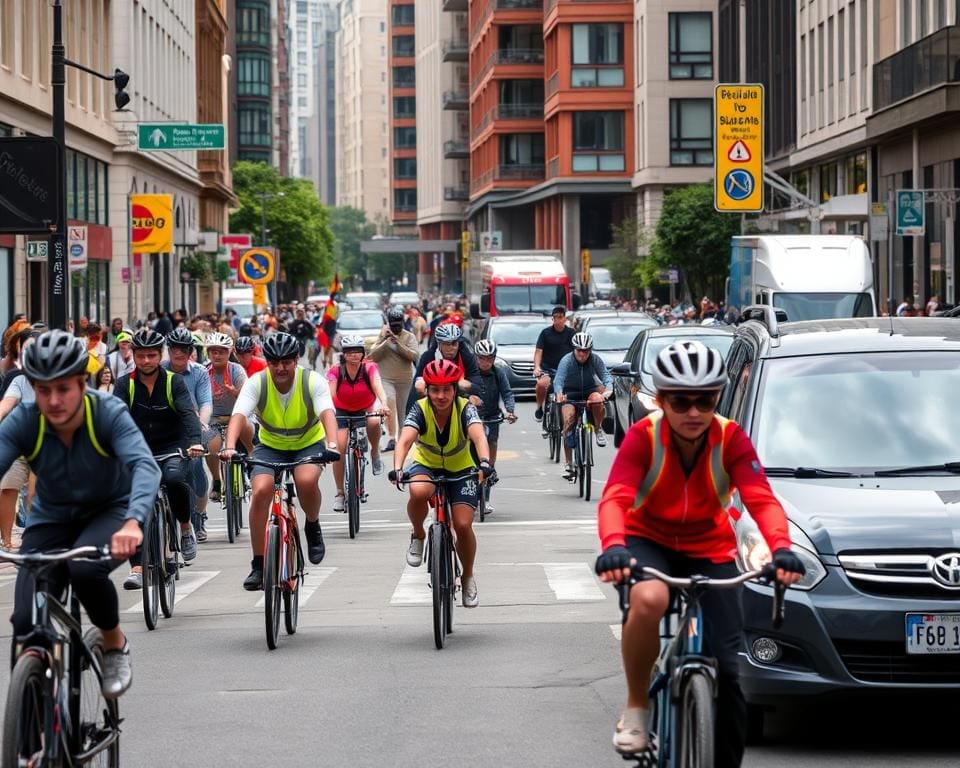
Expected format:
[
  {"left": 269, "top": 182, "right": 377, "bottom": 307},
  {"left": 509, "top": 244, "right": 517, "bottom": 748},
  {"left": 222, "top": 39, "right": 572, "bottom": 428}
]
[{"left": 0, "top": 546, "right": 120, "bottom": 768}]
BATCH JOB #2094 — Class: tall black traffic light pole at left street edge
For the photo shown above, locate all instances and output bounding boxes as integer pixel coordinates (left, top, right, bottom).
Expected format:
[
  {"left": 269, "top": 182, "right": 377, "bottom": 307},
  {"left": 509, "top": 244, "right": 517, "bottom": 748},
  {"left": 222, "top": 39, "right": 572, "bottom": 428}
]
[{"left": 47, "top": 0, "right": 67, "bottom": 328}]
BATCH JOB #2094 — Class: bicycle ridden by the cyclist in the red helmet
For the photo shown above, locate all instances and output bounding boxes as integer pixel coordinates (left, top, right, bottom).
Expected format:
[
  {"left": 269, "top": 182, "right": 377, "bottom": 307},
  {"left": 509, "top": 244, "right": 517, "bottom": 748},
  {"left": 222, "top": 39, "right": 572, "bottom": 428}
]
[{"left": 397, "top": 469, "right": 483, "bottom": 650}]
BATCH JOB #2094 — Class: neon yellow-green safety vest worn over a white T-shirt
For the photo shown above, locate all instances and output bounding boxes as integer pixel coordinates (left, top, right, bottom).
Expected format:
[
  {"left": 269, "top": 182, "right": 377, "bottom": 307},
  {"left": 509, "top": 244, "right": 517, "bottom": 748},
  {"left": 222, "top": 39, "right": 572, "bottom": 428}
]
[{"left": 257, "top": 366, "right": 326, "bottom": 451}]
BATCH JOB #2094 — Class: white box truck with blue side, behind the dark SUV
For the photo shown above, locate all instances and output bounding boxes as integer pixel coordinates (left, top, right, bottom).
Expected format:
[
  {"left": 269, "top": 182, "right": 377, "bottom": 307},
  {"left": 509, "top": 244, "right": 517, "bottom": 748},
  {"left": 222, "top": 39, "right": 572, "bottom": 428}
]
[{"left": 726, "top": 235, "right": 877, "bottom": 320}]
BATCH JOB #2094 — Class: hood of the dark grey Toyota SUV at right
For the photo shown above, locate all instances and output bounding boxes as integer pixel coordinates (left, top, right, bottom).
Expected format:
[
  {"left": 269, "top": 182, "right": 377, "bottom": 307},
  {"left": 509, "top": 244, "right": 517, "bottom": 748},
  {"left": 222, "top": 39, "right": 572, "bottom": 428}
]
[{"left": 770, "top": 476, "right": 960, "bottom": 555}]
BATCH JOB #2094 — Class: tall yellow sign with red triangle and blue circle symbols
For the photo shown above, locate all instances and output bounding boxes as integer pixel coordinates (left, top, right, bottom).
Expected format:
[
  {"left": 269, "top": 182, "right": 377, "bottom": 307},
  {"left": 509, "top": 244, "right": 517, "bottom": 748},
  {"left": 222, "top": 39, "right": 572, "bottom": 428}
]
[{"left": 713, "top": 83, "right": 763, "bottom": 212}]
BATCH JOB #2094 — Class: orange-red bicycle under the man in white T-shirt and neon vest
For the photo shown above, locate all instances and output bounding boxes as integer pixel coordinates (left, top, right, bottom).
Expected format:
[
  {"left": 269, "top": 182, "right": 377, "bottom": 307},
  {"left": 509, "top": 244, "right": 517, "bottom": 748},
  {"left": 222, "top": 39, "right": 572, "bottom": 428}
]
[{"left": 237, "top": 456, "right": 334, "bottom": 651}]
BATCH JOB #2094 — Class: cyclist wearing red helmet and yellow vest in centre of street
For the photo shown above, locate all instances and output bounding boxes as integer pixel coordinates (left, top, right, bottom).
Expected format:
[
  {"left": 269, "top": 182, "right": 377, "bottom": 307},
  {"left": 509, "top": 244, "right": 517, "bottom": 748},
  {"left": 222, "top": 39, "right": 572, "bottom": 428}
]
[{"left": 389, "top": 358, "right": 493, "bottom": 608}]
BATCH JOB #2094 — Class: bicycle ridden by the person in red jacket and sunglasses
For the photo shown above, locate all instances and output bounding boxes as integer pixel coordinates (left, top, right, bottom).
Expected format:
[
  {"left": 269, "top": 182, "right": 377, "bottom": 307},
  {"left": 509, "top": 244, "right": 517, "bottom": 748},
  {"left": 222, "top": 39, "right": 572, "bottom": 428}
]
[{"left": 617, "top": 564, "right": 786, "bottom": 768}]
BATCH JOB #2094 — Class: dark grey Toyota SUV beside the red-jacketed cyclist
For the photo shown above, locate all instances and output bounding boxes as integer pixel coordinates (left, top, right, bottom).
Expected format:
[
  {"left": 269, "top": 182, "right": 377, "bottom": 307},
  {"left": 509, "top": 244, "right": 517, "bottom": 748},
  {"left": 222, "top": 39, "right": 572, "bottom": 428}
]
[{"left": 719, "top": 309, "right": 960, "bottom": 733}]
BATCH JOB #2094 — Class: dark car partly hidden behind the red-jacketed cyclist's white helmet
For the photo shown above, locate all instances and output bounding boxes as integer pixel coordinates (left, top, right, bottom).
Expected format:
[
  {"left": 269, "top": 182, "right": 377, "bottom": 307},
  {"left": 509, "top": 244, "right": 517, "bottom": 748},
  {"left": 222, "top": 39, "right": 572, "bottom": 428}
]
[{"left": 610, "top": 321, "right": 733, "bottom": 447}]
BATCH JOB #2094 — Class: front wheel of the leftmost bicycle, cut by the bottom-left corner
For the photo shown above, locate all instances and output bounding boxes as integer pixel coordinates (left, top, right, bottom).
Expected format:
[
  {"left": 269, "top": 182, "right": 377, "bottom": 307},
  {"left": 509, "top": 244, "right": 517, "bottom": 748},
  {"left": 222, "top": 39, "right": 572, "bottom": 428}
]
[{"left": 0, "top": 654, "right": 47, "bottom": 768}]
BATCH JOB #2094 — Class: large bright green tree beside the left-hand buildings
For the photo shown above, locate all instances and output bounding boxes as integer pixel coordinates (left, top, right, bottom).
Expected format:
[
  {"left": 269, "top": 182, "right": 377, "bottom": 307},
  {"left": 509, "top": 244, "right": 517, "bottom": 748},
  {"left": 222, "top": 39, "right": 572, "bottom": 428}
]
[{"left": 230, "top": 160, "right": 334, "bottom": 294}]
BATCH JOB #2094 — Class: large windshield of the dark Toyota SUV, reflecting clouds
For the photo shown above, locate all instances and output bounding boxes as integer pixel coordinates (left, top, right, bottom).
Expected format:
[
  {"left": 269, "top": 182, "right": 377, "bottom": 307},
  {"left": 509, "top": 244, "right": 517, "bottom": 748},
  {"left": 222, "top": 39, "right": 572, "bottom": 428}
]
[{"left": 753, "top": 351, "right": 960, "bottom": 473}]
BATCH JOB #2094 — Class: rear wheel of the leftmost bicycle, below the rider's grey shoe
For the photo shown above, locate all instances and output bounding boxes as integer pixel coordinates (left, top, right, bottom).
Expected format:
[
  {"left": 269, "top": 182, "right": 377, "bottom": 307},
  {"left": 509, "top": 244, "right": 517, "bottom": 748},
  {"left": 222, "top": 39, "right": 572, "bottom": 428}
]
[{"left": 77, "top": 627, "right": 120, "bottom": 768}]
